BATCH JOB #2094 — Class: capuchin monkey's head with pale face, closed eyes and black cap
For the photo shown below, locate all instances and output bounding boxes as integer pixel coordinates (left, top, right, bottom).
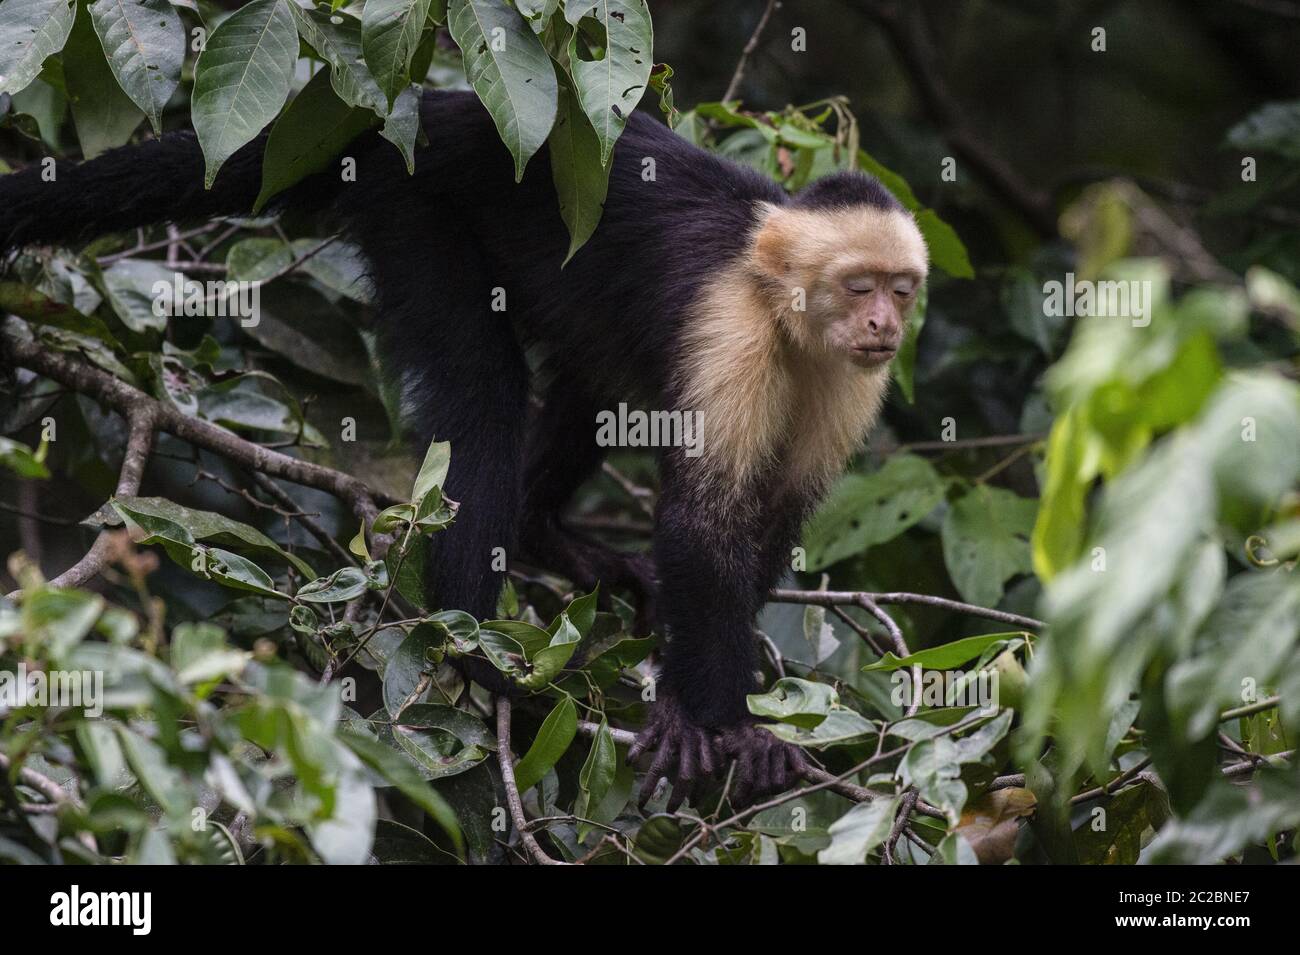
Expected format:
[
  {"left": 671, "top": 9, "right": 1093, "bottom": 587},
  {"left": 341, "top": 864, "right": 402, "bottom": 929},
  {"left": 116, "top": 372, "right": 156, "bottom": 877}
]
[{"left": 754, "top": 173, "right": 930, "bottom": 368}]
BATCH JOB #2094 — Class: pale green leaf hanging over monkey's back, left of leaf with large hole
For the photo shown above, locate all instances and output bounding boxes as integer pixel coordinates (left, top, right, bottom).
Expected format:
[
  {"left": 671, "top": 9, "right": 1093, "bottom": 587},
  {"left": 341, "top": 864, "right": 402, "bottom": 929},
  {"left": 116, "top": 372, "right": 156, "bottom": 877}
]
[{"left": 447, "top": 0, "right": 559, "bottom": 182}]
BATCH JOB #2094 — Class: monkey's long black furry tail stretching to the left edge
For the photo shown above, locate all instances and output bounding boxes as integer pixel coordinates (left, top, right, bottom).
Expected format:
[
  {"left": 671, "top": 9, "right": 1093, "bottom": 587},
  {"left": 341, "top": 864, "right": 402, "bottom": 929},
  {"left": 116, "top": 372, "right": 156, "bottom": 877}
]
[{"left": 0, "top": 133, "right": 329, "bottom": 251}]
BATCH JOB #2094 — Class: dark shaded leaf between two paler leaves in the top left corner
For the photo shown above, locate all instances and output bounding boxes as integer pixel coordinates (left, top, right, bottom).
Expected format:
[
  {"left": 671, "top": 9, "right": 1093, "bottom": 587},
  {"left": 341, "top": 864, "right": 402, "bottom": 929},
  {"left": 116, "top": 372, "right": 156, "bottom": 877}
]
[{"left": 62, "top": 0, "right": 144, "bottom": 159}]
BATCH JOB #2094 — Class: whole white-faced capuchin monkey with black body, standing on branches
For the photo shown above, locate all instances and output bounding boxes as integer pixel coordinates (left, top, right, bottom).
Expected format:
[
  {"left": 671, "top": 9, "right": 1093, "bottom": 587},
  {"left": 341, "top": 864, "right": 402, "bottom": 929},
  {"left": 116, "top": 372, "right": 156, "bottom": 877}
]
[{"left": 0, "top": 92, "right": 928, "bottom": 803}]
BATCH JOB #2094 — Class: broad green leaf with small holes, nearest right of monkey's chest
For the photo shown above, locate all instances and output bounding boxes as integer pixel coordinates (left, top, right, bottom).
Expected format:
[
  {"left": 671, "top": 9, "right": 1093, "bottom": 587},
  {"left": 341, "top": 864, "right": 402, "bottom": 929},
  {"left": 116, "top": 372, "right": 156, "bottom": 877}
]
[{"left": 803, "top": 455, "right": 944, "bottom": 570}]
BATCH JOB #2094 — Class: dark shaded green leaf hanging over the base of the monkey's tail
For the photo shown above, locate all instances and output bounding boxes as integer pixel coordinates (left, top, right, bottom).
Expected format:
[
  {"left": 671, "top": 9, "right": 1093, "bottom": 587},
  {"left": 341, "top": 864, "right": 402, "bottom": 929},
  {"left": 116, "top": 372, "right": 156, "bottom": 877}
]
[{"left": 252, "top": 70, "right": 374, "bottom": 212}]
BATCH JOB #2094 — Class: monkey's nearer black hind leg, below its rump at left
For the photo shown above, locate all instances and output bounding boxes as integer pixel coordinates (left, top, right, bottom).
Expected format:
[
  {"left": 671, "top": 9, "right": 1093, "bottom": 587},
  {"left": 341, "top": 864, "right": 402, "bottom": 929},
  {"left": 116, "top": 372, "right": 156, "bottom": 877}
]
[{"left": 367, "top": 215, "right": 528, "bottom": 647}]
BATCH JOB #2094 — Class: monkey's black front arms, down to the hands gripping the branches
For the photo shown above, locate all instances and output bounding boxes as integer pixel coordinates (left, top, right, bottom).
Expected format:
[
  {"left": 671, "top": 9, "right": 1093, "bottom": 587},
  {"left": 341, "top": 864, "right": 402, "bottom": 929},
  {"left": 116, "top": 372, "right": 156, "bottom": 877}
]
[{"left": 631, "top": 469, "right": 806, "bottom": 807}]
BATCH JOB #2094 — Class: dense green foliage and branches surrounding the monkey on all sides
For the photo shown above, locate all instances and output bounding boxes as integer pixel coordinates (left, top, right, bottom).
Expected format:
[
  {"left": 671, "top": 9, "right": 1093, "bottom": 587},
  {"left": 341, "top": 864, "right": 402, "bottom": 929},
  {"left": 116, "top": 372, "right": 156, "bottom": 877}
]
[{"left": 0, "top": 0, "right": 1300, "bottom": 864}]
